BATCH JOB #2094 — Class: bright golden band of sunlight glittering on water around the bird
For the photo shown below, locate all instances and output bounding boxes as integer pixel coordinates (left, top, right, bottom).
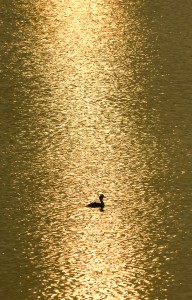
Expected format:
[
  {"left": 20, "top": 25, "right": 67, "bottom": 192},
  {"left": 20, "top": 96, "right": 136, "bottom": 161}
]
[{"left": 25, "top": 1, "right": 170, "bottom": 299}]
